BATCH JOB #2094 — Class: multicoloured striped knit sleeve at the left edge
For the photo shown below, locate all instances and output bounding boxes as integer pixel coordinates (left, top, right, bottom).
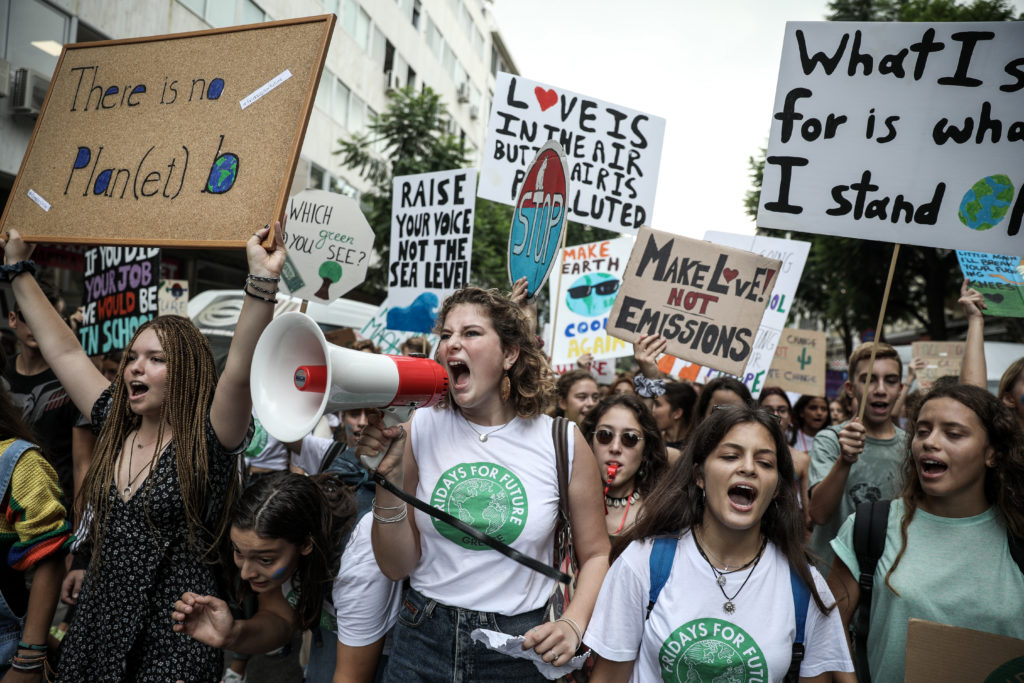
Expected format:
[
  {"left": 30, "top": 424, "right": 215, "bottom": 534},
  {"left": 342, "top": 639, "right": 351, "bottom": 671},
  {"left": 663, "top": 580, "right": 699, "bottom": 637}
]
[{"left": 2, "top": 451, "right": 72, "bottom": 571}]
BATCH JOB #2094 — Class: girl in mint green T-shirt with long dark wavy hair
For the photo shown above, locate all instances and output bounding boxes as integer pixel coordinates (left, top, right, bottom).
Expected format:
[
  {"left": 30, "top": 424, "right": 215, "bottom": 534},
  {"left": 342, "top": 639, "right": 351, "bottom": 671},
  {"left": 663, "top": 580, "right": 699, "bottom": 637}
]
[{"left": 828, "top": 384, "right": 1024, "bottom": 681}]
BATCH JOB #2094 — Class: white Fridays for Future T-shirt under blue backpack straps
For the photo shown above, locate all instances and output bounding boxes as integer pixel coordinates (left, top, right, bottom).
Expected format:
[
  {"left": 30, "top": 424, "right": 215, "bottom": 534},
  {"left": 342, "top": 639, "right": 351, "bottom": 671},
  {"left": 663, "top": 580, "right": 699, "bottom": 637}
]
[{"left": 584, "top": 532, "right": 853, "bottom": 683}]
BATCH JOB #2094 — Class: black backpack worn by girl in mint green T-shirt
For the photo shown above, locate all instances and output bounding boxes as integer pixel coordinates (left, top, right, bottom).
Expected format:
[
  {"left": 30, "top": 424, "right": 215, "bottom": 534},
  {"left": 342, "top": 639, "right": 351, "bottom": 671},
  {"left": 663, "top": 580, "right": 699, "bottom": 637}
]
[{"left": 850, "top": 500, "right": 1024, "bottom": 683}]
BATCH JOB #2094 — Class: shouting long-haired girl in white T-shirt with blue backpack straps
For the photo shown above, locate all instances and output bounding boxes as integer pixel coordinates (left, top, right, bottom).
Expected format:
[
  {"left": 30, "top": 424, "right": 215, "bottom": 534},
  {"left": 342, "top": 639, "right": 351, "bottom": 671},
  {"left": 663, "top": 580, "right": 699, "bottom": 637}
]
[{"left": 586, "top": 405, "right": 853, "bottom": 683}]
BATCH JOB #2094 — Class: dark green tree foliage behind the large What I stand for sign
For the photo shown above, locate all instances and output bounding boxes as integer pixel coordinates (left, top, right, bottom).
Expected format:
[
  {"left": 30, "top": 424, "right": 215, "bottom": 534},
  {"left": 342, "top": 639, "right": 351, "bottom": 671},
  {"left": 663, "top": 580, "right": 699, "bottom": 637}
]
[{"left": 743, "top": 0, "right": 1024, "bottom": 355}]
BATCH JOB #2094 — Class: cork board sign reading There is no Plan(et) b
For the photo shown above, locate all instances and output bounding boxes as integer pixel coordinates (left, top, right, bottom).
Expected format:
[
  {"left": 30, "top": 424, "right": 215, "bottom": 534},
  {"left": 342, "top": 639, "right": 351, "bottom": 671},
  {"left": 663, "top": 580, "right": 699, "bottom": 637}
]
[{"left": 0, "top": 14, "right": 335, "bottom": 248}]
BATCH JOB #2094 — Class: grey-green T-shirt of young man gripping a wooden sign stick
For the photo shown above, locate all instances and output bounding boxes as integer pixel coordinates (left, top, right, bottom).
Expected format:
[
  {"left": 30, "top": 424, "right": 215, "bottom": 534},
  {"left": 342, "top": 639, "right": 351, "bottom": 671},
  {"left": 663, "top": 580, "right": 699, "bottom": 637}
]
[{"left": 808, "top": 425, "right": 906, "bottom": 577}]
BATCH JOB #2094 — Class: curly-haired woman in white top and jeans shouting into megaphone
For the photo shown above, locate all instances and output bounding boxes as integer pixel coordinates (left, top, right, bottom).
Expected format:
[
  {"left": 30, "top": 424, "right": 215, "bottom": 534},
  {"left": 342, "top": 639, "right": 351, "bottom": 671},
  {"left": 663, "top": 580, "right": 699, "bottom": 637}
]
[{"left": 356, "top": 288, "right": 608, "bottom": 681}]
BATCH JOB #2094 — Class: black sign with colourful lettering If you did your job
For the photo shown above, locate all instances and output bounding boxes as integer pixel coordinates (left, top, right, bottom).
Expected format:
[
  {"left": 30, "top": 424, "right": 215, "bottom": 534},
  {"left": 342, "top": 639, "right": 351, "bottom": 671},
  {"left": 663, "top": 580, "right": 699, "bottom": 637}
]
[{"left": 78, "top": 247, "right": 160, "bottom": 355}]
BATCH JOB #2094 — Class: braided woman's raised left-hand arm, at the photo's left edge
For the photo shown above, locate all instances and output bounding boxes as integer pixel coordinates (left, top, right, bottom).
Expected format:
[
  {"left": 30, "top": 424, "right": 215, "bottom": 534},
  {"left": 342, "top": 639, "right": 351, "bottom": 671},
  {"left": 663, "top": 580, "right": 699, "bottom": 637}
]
[{"left": 0, "top": 229, "right": 110, "bottom": 415}]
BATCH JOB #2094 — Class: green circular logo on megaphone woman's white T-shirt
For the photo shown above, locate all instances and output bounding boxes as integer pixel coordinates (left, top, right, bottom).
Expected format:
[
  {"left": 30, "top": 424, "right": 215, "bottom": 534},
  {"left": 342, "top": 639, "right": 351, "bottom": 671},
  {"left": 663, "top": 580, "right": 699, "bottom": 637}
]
[{"left": 430, "top": 463, "right": 527, "bottom": 550}]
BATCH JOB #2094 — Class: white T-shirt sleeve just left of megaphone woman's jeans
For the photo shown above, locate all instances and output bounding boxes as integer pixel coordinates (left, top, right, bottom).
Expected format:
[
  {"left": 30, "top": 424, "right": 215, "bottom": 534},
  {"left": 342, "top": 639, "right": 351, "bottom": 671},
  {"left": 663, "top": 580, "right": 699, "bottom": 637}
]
[{"left": 333, "top": 514, "right": 401, "bottom": 647}]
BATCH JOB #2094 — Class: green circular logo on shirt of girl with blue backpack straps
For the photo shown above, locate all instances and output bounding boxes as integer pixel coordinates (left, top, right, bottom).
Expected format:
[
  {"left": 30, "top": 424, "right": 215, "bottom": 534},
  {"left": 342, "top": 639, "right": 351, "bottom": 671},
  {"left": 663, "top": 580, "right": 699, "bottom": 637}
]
[{"left": 657, "top": 618, "right": 768, "bottom": 683}]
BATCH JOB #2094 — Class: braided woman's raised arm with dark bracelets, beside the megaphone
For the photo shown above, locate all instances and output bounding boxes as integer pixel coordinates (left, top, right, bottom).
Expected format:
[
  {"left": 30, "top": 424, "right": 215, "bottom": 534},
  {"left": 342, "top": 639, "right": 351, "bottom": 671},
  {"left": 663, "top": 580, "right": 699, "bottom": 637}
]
[{"left": 210, "top": 223, "right": 285, "bottom": 449}]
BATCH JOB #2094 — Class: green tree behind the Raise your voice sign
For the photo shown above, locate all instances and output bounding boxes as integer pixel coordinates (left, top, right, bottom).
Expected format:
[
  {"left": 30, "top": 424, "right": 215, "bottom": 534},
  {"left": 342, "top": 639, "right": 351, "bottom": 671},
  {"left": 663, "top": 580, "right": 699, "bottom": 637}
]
[{"left": 335, "top": 83, "right": 617, "bottom": 302}]
